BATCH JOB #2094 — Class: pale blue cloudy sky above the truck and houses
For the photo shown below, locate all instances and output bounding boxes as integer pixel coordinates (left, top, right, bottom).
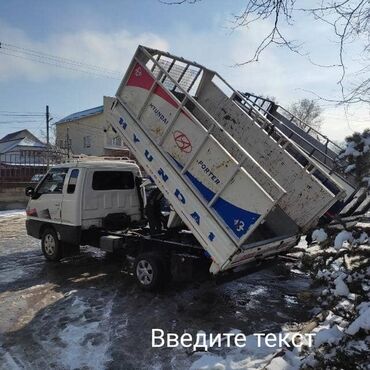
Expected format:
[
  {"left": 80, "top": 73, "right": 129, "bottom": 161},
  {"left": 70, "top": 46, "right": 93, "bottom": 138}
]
[{"left": 0, "top": 0, "right": 370, "bottom": 141}]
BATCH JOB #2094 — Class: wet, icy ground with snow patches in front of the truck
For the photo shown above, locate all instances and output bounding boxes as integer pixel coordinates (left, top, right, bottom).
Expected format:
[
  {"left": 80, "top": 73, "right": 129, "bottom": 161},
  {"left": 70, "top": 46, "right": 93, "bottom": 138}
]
[{"left": 0, "top": 213, "right": 316, "bottom": 370}]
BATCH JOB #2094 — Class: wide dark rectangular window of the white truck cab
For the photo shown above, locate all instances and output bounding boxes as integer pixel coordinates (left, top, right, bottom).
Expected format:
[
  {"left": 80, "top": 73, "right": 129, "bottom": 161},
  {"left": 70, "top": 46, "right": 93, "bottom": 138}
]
[{"left": 92, "top": 171, "right": 135, "bottom": 190}]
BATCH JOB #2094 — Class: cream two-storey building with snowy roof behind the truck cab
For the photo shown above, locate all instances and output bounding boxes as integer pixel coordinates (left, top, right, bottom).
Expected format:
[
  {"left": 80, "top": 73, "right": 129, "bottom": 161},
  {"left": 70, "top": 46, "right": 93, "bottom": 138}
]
[{"left": 56, "top": 96, "right": 130, "bottom": 156}]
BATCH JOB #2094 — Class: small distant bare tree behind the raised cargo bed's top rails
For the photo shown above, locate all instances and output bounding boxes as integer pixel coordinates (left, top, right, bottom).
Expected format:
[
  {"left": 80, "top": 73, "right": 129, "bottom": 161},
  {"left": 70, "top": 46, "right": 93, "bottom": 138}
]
[{"left": 289, "top": 99, "right": 322, "bottom": 131}]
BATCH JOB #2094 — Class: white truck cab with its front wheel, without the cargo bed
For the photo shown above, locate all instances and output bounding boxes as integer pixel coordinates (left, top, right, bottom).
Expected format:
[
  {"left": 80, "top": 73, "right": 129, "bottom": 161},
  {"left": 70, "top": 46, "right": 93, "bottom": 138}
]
[{"left": 26, "top": 159, "right": 145, "bottom": 261}]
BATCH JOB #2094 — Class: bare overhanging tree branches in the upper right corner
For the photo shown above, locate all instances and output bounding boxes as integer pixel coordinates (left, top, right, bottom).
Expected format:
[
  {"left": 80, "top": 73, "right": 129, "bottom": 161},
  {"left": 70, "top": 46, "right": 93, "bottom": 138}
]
[{"left": 160, "top": 0, "right": 370, "bottom": 104}]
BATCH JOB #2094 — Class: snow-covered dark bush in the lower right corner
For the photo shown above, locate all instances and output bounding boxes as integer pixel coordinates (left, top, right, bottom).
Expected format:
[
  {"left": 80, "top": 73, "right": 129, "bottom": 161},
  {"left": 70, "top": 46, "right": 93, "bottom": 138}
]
[{"left": 300, "top": 227, "right": 370, "bottom": 370}]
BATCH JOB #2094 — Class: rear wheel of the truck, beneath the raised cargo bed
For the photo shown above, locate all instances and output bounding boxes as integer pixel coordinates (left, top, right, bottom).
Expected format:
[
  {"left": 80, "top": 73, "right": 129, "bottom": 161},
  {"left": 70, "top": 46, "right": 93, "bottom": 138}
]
[{"left": 134, "top": 253, "right": 165, "bottom": 290}]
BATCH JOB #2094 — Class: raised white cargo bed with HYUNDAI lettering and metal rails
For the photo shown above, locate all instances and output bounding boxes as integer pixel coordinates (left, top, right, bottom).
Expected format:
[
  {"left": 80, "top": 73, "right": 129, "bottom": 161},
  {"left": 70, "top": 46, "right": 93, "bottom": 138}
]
[{"left": 110, "top": 46, "right": 343, "bottom": 273}]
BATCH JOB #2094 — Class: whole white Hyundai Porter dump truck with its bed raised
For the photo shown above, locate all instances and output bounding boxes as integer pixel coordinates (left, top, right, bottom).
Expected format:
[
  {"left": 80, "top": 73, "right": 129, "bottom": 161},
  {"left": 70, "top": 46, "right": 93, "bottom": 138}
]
[{"left": 27, "top": 46, "right": 346, "bottom": 288}]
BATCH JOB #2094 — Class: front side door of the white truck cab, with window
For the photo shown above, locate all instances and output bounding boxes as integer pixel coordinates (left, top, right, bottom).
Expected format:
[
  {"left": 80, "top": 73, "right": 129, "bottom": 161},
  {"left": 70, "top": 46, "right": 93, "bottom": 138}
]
[{"left": 29, "top": 168, "right": 68, "bottom": 222}]
